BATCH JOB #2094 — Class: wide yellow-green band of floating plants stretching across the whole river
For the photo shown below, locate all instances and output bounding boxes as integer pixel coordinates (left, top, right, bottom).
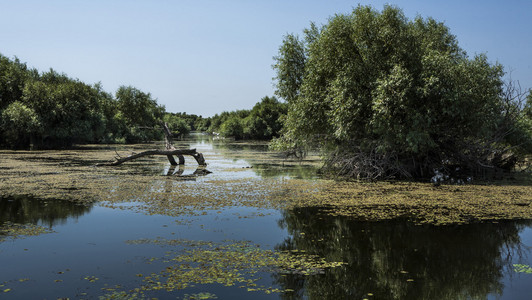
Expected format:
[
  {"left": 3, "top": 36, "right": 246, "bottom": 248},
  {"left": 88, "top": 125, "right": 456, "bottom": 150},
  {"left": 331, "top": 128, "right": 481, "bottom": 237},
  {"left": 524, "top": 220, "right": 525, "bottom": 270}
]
[{"left": 0, "top": 146, "right": 532, "bottom": 225}]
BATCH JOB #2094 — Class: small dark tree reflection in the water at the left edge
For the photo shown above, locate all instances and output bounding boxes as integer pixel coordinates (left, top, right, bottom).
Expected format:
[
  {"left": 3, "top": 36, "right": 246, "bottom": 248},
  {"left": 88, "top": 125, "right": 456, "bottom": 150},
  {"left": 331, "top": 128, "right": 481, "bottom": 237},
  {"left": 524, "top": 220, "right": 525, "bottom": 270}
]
[{"left": 0, "top": 197, "right": 92, "bottom": 227}]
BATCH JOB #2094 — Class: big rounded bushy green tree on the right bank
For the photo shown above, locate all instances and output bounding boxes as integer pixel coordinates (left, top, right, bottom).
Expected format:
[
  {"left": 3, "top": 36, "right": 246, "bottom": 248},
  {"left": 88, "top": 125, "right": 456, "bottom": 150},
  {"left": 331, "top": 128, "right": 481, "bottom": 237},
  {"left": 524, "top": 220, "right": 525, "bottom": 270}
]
[{"left": 274, "top": 6, "right": 528, "bottom": 176}]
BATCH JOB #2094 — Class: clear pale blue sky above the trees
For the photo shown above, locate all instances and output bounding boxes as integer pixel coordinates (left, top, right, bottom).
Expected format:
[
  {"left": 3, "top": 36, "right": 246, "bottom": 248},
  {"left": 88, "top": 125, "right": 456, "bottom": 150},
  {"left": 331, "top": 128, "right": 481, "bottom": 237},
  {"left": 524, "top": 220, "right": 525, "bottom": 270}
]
[{"left": 0, "top": 0, "right": 532, "bottom": 116}]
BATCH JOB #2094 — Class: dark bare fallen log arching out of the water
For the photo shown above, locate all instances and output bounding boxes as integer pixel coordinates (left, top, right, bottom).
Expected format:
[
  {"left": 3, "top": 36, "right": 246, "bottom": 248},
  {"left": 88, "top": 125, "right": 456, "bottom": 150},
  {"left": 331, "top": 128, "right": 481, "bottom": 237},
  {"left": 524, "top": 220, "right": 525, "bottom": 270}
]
[{"left": 96, "top": 123, "right": 207, "bottom": 166}]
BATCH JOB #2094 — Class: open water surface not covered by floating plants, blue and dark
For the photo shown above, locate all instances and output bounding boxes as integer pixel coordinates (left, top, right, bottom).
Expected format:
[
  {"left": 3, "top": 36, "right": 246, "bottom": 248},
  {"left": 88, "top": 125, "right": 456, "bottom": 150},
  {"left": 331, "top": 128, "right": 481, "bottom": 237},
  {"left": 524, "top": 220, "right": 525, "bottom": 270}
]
[{"left": 0, "top": 136, "right": 532, "bottom": 299}]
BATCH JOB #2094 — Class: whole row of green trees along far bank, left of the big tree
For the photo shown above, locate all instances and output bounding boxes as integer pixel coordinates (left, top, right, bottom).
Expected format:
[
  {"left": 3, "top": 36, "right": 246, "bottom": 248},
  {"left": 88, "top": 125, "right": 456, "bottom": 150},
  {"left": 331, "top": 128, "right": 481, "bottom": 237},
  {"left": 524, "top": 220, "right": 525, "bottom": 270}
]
[{"left": 0, "top": 54, "right": 286, "bottom": 149}]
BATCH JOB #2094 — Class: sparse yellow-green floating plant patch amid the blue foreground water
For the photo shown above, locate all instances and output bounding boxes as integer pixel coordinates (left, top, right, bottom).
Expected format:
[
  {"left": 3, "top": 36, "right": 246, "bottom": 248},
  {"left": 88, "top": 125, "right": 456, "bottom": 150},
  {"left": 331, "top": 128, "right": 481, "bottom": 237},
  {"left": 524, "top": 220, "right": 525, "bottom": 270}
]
[{"left": 128, "top": 239, "right": 345, "bottom": 299}]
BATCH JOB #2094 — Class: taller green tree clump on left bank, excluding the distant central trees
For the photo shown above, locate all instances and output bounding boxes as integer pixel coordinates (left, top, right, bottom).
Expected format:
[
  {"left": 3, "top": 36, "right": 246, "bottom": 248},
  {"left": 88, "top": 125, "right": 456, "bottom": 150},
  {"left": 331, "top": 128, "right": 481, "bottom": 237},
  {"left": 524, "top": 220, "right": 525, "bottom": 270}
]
[{"left": 0, "top": 55, "right": 165, "bottom": 148}]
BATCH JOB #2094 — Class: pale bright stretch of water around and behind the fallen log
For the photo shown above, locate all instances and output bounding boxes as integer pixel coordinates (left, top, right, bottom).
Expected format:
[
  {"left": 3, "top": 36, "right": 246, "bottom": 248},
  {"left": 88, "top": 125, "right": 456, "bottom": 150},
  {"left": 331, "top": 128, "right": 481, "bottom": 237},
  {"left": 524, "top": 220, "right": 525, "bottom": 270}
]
[{"left": 92, "top": 133, "right": 319, "bottom": 180}]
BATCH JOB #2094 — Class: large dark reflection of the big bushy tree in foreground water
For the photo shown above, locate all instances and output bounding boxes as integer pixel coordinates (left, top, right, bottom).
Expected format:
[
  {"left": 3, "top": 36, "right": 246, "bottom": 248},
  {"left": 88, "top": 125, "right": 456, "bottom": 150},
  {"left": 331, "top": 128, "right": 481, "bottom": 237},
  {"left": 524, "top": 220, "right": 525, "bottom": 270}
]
[{"left": 274, "top": 208, "right": 532, "bottom": 299}]
